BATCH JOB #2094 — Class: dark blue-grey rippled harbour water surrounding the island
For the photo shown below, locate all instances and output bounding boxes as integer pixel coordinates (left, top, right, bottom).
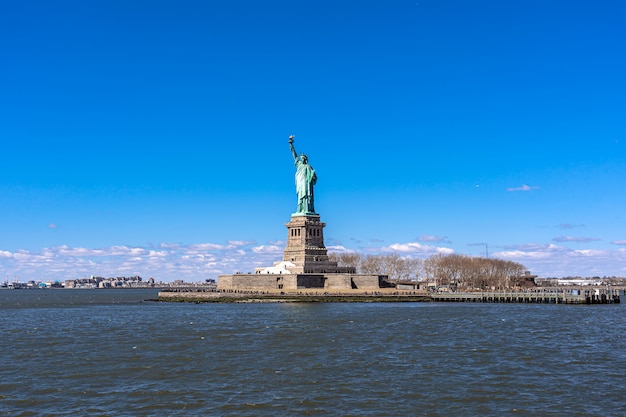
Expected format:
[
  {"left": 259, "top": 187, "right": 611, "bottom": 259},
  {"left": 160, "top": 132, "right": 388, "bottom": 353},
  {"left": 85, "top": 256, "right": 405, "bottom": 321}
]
[{"left": 0, "top": 290, "right": 626, "bottom": 416}]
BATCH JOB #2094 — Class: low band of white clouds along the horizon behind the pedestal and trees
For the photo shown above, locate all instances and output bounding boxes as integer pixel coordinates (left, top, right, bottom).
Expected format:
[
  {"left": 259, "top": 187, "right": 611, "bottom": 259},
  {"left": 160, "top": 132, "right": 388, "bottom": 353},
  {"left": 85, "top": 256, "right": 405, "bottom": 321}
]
[{"left": 0, "top": 236, "right": 626, "bottom": 282}]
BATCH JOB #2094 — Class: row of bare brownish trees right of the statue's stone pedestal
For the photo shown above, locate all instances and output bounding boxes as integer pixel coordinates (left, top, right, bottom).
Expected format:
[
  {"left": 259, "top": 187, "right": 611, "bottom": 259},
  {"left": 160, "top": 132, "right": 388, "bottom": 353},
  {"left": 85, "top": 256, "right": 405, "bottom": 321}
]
[{"left": 328, "top": 253, "right": 526, "bottom": 290}]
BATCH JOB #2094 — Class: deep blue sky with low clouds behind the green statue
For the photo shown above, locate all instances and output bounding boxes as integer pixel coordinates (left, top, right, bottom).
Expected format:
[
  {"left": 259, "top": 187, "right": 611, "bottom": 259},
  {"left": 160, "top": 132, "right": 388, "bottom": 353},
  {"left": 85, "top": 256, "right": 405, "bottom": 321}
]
[{"left": 0, "top": 0, "right": 626, "bottom": 281}]
